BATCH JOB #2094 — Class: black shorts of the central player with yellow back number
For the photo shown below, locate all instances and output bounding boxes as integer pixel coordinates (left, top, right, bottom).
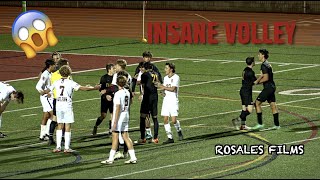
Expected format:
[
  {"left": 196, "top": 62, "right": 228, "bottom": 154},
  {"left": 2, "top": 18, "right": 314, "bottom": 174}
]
[{"left": 140, "top": 94, "right": 158, "bottom": 116}]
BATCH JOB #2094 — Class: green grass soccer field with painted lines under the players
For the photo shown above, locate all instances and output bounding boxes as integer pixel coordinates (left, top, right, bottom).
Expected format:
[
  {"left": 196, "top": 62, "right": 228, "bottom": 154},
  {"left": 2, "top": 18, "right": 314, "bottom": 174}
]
[{"left": 0, "top": 35, "right": 320, "bottom": 179}]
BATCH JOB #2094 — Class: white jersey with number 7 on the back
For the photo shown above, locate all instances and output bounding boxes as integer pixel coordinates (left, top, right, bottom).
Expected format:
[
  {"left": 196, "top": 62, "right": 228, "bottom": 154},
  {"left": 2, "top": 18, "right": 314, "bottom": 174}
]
[{"left": 50, "top": 79, "right": 80, "bottom": 111}]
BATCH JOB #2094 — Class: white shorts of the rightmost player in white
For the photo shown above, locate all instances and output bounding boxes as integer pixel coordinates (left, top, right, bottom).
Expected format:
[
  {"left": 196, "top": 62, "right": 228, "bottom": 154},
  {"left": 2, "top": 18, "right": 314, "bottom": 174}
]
[{"left": 161, "top": 98, "right": 179, "bottom": 117}]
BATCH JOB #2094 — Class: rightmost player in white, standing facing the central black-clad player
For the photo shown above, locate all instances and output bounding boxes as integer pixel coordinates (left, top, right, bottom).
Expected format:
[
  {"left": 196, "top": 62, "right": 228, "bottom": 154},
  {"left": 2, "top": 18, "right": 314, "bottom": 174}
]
[{"left": 159, "top": 63, "right": 183, "bottom": 144}]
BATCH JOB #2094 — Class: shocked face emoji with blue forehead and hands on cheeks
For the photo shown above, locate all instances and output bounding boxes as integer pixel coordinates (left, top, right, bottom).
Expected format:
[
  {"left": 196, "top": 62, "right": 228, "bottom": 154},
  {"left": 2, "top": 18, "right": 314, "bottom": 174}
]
[{"left": 12, "top": 10, "right": 58, "bottom": 58}]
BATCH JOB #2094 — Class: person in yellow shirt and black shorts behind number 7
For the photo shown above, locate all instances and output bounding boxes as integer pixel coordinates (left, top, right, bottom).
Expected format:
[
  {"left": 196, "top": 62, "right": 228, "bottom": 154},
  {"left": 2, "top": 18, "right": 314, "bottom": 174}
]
[{"left": 48, "top": 58, "right": 71, "bottom": 145}]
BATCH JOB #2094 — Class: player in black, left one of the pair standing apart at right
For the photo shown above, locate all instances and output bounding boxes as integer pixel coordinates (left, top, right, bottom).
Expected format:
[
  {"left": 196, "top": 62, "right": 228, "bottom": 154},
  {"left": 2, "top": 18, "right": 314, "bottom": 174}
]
[{"left": 232, "top": 57, "right": 257, "bottom": 130}]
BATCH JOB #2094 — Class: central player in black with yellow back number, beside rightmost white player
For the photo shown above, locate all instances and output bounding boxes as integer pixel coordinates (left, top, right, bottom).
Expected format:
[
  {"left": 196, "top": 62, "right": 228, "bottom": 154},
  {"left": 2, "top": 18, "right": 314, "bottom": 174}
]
[{"left": 139, "top": 62, "right": 159, "bottom": 144}]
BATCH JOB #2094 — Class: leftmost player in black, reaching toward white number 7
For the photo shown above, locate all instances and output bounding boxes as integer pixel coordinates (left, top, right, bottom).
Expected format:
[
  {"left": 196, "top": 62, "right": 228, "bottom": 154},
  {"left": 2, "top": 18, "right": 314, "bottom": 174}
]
[{"left": 92, "top": 64, "right": 115, "bottom": 135}]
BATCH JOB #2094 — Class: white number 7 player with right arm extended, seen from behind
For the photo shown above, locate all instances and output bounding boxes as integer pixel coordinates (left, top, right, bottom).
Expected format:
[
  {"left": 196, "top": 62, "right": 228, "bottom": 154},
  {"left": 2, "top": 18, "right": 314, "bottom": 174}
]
[{"left": 47, "top": 65, "right": 100, "bottom": 153}]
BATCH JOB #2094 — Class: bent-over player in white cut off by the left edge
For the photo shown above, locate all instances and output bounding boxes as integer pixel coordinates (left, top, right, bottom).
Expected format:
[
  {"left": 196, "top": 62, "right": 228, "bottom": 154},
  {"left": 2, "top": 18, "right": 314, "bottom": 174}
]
[{"left": 0, "top": 82, "right": 24, "bottom": 138}]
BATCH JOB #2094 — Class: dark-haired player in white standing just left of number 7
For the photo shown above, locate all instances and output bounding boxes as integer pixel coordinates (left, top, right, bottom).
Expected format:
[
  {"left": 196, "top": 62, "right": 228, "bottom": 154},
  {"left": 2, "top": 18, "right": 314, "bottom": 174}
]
[{"left": 36, "top": 59, "right": 56, "bottom": 141}]
